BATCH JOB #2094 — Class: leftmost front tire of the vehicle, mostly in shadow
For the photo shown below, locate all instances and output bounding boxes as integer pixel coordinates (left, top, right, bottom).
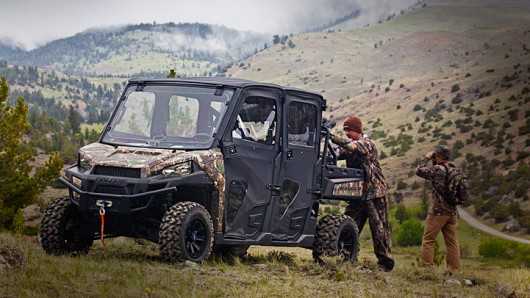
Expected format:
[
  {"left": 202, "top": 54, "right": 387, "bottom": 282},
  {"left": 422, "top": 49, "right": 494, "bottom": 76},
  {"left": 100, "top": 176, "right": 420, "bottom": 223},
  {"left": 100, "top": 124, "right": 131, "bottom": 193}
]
[{"left": 39, "top": 198, "right": 94, "bottom": 255}]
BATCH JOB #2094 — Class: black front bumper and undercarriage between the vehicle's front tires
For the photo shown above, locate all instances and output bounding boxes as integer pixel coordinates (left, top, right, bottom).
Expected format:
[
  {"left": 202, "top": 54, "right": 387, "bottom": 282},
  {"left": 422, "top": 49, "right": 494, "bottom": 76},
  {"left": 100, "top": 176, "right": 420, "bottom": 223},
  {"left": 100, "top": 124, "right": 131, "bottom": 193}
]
[{"left": 59, "top": 166, "right": 212, "bottom": 242}]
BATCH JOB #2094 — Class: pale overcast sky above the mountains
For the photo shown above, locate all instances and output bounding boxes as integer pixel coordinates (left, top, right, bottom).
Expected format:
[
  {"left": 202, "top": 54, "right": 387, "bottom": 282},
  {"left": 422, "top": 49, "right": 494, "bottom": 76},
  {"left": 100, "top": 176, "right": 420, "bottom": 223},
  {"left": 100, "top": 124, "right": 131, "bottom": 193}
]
[{"left": 0, "top": 0, "right": 415, "bottom": 49}]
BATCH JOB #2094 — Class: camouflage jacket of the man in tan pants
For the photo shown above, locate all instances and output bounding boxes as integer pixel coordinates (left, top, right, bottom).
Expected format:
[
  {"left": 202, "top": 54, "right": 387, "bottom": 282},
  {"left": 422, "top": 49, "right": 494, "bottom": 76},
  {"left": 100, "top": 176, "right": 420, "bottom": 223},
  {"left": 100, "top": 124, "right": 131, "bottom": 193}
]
[{"left": 416, "top": 161, "right": 457, "bottom": 215}]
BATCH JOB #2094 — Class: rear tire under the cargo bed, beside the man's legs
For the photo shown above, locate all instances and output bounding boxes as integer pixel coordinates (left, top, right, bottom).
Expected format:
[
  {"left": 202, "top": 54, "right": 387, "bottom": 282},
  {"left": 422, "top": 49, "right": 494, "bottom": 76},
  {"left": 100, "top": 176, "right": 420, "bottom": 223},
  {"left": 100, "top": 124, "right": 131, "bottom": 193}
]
[{"left": 313, "top": 214, "right": 359, "bottom": 264}]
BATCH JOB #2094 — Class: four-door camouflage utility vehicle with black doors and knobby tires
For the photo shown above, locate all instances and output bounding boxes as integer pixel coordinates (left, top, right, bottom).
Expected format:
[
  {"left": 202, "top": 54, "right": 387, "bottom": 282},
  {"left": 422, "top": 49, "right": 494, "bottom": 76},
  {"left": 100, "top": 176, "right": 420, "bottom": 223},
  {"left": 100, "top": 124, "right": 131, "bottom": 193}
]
[{"left": 40, "top": 78, "right": 365, "bottom": 262}]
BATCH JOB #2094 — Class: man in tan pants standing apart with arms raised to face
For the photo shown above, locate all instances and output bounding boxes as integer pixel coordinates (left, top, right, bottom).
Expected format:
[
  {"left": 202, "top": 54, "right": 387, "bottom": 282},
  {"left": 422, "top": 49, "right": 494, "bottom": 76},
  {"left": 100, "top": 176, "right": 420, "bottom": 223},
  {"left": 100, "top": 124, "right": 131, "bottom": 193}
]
[{"left": 416, "top": 146, "right": 460, "bottom": 273}]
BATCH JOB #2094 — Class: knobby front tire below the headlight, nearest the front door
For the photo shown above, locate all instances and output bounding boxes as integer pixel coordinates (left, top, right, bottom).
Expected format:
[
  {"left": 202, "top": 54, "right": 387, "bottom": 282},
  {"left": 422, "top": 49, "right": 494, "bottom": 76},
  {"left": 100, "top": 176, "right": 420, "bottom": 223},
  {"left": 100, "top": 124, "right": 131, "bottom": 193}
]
[{"left": 159, "top": 202, "right": 214, "bottom": 262}]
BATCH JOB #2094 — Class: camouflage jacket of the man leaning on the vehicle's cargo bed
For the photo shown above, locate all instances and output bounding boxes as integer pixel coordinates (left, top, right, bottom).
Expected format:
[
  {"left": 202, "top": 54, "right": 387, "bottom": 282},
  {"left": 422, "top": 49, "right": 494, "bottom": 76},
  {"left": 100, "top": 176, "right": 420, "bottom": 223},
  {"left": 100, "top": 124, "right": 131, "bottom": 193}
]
[{"left": 333, "top": 136, "right": 388, "bottom": 198}]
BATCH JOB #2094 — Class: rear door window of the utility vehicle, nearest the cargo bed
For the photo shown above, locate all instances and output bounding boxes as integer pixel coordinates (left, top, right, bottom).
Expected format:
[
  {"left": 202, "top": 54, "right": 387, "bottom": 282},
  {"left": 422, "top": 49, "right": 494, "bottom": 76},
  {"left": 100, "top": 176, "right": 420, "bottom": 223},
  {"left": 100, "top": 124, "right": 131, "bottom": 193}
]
[{"left": 287, "top": 102, "right": 317, "bottom": 147}]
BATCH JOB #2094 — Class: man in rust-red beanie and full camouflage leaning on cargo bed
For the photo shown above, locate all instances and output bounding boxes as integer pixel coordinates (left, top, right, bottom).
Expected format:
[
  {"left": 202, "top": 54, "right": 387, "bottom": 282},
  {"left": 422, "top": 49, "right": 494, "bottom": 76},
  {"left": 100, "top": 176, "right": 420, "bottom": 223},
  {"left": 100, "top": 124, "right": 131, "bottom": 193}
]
[{"left": 332, "top": 116, "right": 394, "bottom": 271}]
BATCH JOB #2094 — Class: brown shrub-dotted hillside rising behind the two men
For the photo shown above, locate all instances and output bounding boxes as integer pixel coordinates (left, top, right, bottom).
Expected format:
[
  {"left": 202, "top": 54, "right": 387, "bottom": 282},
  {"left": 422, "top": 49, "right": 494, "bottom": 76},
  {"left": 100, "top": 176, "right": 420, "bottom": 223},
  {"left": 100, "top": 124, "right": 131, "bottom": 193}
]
[{"left": 228, "top": 0, "right": 530, "bottom": 232}]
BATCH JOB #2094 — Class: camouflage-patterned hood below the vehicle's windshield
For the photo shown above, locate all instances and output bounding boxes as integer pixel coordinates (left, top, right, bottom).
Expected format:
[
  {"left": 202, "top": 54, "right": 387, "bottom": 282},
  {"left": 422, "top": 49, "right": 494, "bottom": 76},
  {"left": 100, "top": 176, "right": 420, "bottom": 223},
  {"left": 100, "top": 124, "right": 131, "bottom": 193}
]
[{"left": 79, "top": 143, "right": 222, "bottom": 177}]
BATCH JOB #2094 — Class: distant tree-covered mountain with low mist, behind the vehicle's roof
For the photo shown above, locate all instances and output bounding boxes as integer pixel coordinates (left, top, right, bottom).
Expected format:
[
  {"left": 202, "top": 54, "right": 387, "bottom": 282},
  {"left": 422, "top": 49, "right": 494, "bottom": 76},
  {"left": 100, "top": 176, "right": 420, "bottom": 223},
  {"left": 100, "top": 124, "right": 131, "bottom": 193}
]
[{"left": 0, "top": 23, "right": 270, "bottom": 75}]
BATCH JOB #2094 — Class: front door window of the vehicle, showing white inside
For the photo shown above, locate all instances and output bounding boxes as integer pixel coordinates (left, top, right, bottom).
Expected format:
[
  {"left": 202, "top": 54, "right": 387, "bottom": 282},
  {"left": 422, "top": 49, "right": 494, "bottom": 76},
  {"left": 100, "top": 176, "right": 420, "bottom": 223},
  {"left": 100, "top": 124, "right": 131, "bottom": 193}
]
[{"left": 232, "top": 97, "right": 276, "bottom": 145}]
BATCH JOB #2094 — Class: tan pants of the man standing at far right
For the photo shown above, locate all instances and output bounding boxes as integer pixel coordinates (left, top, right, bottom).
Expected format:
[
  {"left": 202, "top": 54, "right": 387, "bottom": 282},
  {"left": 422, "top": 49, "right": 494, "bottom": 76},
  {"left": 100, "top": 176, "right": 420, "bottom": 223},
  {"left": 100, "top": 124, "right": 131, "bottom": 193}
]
[{"left": 421, "top": 214, "right": 460, "bottom": 272}]
